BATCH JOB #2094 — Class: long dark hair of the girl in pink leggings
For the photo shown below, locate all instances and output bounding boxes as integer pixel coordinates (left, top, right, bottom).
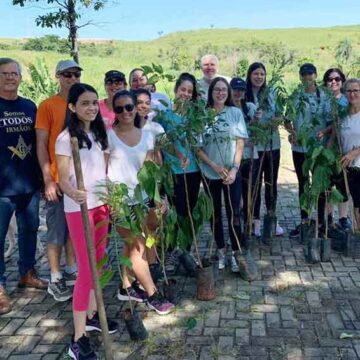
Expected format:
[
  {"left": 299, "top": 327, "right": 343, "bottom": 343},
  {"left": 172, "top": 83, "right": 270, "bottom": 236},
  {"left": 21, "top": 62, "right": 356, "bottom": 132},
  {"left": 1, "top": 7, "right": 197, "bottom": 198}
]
[{"left": 65, "top": 83, "right": 108, "bottom": 150}]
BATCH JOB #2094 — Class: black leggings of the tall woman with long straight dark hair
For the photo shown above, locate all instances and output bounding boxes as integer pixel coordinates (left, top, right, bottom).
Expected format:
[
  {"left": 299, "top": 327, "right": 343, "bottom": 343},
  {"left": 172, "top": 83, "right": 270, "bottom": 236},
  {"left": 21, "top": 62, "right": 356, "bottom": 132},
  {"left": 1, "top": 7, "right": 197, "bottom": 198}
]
[{"left": 254, "top": 150, "right": 280, "bottom": 219}]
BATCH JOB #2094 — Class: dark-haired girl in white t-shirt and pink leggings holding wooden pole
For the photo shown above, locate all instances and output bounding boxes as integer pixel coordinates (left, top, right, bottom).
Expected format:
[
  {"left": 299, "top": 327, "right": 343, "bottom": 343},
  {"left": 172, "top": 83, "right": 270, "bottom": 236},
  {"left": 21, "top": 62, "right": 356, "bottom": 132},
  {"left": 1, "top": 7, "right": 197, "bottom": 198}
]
[{"left": 55, "top": 84, "right": 117, "bottom": 359}]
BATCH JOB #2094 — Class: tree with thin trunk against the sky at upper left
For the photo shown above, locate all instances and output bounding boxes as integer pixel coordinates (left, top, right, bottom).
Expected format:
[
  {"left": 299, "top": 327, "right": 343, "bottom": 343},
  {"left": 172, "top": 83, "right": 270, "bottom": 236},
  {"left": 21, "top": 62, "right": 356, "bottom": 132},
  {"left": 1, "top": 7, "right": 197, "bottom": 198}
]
[{"left": 13, "top": 0, "right": 108, "bottom": 62}]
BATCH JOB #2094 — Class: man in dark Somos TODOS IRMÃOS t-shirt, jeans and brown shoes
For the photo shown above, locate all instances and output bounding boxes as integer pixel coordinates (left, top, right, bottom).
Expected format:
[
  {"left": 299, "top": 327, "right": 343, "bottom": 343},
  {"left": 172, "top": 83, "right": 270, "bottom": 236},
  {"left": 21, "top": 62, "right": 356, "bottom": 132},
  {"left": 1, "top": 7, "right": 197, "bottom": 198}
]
[{"left": 0, "top": 58, "right": 47, "bottom": 314}]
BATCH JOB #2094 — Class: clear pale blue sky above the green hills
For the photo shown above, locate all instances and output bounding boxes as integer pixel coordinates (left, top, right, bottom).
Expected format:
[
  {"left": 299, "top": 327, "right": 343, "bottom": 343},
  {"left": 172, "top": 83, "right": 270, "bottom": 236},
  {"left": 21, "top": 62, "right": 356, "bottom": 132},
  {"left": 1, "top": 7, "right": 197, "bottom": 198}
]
[{"left": 0, "top": 0, "right": 360, "bottom": 40}]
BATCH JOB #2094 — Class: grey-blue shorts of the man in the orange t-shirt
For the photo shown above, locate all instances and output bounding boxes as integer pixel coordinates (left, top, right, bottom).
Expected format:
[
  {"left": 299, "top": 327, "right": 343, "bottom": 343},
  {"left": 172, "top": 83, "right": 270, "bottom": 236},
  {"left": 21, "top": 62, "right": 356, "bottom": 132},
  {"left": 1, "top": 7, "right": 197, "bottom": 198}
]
[{"left": 46, "top": 196, "right": 69, "bottom": 246}]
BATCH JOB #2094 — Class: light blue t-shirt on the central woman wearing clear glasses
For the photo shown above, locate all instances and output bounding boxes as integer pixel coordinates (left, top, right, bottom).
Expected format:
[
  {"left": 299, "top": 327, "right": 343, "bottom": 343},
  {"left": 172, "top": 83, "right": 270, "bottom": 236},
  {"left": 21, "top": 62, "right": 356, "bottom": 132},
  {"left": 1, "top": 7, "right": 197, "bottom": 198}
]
[{"left": 199, "top": 106, "right": 248, "bottom": 180}]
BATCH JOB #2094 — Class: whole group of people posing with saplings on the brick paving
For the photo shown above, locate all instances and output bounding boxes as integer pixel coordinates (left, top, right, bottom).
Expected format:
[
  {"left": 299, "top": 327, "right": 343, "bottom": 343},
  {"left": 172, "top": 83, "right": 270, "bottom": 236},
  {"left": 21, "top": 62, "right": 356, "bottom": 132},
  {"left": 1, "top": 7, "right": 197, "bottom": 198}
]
[{"left": 0, "top": 54, "right": 360, "bottom": 359}]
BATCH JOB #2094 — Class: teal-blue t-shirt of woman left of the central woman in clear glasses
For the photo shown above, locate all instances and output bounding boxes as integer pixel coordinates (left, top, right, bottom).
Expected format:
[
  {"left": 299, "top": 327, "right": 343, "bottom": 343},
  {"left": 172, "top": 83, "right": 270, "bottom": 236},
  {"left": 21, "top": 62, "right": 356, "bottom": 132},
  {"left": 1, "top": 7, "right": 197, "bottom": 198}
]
[{"left": 160, "top": 110, "right": 200, "bottom": 174}]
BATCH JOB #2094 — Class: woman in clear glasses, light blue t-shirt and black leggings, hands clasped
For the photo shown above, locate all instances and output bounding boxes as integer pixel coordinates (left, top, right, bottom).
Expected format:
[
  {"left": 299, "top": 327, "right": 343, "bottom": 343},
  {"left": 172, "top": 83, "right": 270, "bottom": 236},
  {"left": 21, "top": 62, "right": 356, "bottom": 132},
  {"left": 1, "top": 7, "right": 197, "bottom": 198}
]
[{"left": 198, "top": 77, "right": 257, "bottom": 281}]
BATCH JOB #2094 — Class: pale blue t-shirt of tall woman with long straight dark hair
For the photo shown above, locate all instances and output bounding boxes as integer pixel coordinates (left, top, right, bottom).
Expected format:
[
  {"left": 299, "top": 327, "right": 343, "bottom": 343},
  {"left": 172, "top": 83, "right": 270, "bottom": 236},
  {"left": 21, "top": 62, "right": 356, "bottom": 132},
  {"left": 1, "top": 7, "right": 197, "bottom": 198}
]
[{"left": 254, "top": 90, "right": 282, "bottom": 151}]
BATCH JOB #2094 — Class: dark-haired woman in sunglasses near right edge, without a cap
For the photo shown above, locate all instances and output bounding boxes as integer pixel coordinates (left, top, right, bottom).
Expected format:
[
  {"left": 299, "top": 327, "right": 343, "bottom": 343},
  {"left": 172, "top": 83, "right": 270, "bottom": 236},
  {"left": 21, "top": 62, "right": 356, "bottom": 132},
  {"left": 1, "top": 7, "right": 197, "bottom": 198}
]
[{"left": 323, "top": 68, "right": 351, "bottom": 231}]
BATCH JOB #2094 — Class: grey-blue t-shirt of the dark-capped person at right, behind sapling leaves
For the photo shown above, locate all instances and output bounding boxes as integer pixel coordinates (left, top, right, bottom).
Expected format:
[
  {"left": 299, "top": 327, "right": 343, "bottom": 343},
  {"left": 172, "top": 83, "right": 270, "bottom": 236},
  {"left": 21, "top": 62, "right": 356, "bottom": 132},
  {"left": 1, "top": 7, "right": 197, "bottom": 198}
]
[{"left": 291, "top": 89, "right": 333, "bottom": 153}]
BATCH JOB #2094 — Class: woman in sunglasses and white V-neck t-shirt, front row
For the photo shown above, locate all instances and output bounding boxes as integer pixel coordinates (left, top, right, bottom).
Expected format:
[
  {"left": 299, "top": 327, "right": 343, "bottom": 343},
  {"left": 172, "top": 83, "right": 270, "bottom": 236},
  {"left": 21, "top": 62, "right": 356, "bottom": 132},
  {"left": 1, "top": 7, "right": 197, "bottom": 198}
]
[{"left": 108, "top": 90, "right": 174, "bottom": 315}]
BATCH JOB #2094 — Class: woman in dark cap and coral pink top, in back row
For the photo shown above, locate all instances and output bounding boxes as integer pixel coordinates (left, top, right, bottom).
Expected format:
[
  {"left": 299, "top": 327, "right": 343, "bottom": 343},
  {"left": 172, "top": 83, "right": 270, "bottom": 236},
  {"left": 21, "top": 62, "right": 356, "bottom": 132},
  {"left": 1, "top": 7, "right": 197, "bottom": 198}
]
[{"left": 99, "top": 70, "right": 127, "bottom": 129}]
